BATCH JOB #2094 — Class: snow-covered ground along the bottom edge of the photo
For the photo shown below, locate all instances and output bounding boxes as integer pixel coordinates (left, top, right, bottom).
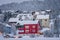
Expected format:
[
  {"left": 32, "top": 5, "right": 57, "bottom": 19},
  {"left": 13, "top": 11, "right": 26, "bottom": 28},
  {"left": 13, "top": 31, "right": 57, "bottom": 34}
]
[{"left": 0, "top": 35, "right": 60, "bottom": 40}]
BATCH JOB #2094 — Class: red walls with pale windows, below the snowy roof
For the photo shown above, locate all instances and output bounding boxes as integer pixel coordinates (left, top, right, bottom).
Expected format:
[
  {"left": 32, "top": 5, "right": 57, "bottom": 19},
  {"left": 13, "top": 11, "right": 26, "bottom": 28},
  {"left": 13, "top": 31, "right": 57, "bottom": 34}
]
[{"left": 19, "top": 24, "right": 39, "bottom": 34}]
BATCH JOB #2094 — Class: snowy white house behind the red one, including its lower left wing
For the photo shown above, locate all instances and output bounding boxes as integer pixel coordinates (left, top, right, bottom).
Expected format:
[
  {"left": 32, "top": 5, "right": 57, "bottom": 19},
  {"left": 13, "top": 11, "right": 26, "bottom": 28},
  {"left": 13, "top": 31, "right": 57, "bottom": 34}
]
[{"left": 9, "top": 14, "right": 33, "bottom": 25}]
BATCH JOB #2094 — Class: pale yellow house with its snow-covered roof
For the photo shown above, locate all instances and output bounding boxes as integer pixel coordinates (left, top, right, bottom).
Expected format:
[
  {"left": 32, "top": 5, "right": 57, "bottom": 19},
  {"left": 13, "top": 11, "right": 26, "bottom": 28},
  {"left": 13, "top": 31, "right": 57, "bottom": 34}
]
[{"left": 36, "top": 15, "right": 49, "bottom": 27}]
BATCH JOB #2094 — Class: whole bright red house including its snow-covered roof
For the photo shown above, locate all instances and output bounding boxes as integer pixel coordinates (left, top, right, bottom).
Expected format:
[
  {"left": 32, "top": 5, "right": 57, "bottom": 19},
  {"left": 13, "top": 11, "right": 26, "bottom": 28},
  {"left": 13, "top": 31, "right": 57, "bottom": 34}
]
[{"left": 18, "top": 21, "right": 40, "bottom": 34}]
